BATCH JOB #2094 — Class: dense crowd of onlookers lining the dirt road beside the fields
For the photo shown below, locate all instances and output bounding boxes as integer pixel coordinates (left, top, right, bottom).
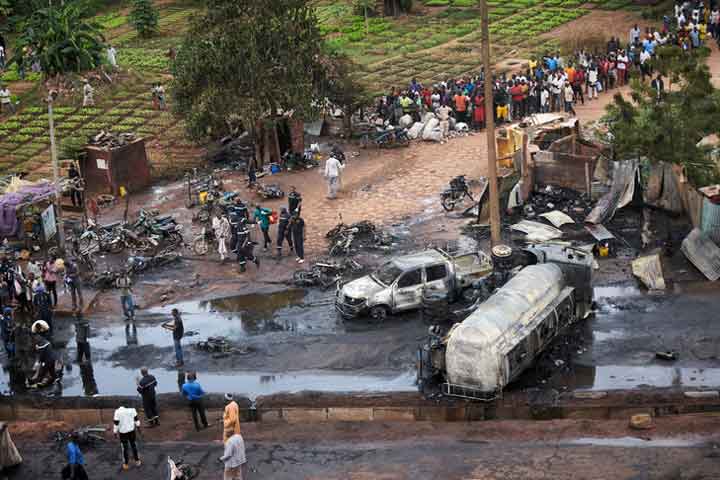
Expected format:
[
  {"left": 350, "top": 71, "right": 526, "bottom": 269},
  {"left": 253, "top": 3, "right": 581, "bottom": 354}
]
[{"left": 375, "top": 1, "right": 720, "bottom": 136}]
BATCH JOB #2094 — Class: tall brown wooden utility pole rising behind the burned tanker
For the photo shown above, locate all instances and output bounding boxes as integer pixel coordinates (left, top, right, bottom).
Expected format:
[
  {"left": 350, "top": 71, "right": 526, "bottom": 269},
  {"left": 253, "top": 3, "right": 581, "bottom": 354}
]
[{"left": 480, "top": 0, "right": 502, "bottom": 246}]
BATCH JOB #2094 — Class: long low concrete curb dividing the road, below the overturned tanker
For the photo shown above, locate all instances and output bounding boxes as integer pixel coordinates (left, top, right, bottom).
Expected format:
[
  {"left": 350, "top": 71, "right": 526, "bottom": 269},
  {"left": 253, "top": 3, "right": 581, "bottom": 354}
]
[{"left": 0, "top": 390, "right": 720, "bottom": 425}]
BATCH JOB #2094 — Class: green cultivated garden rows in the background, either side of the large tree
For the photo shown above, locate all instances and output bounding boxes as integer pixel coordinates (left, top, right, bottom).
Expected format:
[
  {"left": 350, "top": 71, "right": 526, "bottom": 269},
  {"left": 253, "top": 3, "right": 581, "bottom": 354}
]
[{"left": 0, "top": 0, "right": 631, "bottom": 177}]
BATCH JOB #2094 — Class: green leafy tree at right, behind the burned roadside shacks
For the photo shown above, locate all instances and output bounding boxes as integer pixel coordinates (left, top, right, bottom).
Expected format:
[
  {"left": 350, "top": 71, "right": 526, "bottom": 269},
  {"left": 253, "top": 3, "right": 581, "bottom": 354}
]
[{"left": 606, "top": 46, "right": 720, "bottom": 186}]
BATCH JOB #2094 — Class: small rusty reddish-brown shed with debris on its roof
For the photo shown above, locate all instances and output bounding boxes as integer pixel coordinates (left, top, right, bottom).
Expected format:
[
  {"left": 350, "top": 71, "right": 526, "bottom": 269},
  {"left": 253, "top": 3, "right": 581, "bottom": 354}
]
[{"left": 80, "top": 138, "right": 150, "bottom": 195}]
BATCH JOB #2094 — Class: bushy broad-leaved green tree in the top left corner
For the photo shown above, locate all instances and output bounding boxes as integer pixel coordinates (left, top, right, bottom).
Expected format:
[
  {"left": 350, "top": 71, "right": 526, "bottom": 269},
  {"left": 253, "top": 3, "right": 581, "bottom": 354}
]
[{"left": 10, "top": 3, "right": 105, "bottom": 77}]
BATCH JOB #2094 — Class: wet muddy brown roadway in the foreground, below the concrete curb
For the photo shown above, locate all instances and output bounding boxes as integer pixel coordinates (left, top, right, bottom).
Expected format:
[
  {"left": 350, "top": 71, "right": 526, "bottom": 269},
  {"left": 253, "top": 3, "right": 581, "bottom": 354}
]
[{"left": 11, "top": 416, "right": 720, "bottom": 480}]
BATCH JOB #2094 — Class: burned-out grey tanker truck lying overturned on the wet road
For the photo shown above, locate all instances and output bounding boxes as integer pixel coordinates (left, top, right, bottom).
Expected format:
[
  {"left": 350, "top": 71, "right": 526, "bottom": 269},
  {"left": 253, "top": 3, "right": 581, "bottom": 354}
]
[{"left": 418, "top": 245, "right": 593, "bottom": 400}]
